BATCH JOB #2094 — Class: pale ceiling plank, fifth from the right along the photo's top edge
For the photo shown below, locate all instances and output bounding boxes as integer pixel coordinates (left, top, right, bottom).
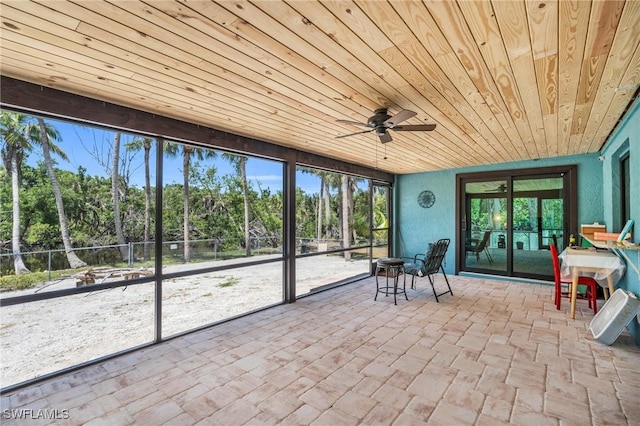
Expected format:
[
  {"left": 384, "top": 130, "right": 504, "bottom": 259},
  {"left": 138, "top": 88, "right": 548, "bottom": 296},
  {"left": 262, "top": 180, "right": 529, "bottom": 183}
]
[{"left": 491, "top": 0, "right": 546, "bottom": 158}]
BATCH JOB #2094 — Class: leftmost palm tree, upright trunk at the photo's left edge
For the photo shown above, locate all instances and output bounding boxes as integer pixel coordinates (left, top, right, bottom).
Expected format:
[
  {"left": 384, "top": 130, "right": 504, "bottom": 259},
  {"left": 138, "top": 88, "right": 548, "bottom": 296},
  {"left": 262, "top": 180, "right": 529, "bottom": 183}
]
[{"left": 0, "top": 111, "right": 32, "bottom": 275}]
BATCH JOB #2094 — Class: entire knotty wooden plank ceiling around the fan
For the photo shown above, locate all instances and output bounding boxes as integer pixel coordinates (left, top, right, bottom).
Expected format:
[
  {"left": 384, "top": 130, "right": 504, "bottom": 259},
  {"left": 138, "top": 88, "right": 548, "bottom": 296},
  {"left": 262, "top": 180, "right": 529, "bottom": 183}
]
[{"left": 0, "top": 0, "right": 640, "bottom": 174}]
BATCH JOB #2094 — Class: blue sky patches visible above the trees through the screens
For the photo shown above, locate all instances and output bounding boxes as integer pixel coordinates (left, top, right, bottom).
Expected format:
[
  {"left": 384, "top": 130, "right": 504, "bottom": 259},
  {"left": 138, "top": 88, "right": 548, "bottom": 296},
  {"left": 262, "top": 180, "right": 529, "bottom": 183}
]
[{"left": 27, "top": 119, "right": 320, "bottom": 193}]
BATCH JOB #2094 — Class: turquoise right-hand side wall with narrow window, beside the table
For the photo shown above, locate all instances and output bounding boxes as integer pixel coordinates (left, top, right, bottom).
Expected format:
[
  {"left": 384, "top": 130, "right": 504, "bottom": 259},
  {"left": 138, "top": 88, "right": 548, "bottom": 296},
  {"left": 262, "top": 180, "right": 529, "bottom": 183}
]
[{"left": 602, "top": 98, "right": 640, "bottom": 345}]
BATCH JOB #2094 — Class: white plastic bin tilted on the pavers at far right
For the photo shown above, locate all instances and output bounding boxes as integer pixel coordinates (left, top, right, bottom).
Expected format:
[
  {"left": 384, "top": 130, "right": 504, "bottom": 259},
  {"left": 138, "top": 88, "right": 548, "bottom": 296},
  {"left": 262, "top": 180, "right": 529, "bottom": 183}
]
[{"left": 589, "top": 288, "right": 640, "bottom": 345}]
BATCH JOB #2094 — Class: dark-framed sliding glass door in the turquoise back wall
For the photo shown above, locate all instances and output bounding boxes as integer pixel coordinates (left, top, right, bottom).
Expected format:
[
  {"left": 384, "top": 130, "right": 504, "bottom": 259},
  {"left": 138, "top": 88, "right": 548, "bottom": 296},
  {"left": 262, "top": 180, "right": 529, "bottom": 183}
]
[{"left": 456, "top": 166, "right": 577, "bottom": 279}]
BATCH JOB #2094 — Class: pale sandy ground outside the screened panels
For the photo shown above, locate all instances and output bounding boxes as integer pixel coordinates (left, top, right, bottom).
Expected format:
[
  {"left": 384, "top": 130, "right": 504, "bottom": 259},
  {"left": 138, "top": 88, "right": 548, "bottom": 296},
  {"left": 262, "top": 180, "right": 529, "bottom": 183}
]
[{"left": 0, "top": 256, "right": 368, "bottom": 388}]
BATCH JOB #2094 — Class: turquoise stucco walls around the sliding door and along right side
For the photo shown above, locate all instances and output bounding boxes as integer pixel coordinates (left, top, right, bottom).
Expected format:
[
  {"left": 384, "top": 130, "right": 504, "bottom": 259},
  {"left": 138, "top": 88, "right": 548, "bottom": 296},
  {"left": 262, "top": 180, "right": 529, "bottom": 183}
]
[{"left": 394, "top": 98, "right": 640, "bottom": 345}]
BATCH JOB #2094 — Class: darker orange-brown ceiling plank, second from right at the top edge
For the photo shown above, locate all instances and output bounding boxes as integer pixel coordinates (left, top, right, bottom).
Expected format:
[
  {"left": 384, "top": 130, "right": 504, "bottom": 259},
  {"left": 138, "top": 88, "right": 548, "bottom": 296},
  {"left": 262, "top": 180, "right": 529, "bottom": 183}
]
[{"left": 571, "top": 0, "right": 624, "bottom": 152}]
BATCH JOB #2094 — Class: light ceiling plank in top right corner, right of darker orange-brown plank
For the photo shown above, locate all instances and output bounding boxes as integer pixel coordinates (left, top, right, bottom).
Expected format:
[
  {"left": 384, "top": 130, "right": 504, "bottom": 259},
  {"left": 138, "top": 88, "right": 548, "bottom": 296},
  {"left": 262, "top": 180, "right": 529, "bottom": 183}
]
[{"left": 580, "top": 1, "right": 640, "bottom": 152}]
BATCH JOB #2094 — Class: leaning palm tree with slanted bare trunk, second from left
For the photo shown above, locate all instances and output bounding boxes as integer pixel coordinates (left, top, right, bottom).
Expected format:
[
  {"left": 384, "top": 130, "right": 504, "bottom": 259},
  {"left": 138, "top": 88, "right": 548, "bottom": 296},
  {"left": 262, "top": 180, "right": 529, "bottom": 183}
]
[{"left": 34, "top": 117, "right": 87, "bottom": 269}]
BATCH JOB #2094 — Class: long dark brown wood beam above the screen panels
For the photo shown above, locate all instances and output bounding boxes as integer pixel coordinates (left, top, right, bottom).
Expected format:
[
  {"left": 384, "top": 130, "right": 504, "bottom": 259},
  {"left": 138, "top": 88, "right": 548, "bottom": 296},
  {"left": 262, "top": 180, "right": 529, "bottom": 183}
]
[{"left": 0, "top": 76, "right": 394, "bottom": 183}]
